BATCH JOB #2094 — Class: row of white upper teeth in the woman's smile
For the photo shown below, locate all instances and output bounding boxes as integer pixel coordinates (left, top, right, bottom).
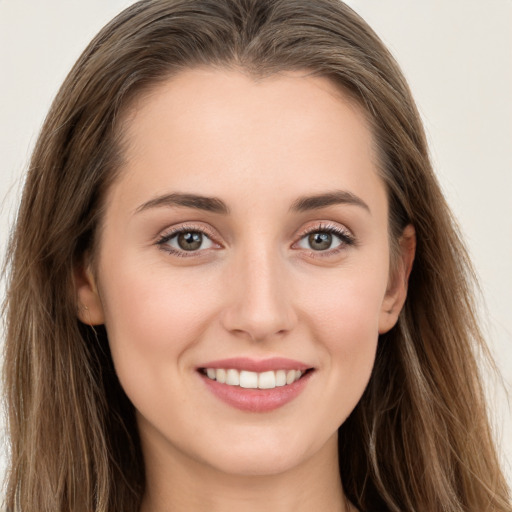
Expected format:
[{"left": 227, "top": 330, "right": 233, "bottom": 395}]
[{"left": 206, "top": 368, "right": 303, "bottom": 389}]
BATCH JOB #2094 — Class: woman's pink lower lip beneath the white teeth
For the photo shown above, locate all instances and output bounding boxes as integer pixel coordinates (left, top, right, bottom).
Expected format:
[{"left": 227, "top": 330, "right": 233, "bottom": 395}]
[{"left": 200, "top": 371, "right": 313, "bottom": 412}]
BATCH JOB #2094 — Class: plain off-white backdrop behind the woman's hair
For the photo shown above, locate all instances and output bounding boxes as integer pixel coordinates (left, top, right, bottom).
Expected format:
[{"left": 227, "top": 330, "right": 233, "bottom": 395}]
[{"left": 0, "top": 0, "right": 512, "bottom": 482}]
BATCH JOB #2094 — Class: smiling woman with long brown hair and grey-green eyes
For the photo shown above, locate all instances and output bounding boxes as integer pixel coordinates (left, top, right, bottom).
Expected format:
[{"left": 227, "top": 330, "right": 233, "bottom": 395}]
[{"left": 5, "top": 0, "right": 511, "bottom": 512}]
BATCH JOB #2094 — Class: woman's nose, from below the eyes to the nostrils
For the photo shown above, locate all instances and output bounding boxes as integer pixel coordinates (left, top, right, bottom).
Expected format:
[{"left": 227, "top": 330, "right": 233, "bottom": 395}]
[{"left": 222, "top": 248, "right": 297, "bottom": 341}]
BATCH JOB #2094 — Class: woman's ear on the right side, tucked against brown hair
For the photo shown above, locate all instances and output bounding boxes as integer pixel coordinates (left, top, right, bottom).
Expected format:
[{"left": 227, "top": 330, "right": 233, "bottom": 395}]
[{"left": 379, "top": 224, "right": 416, "bottom": 334}]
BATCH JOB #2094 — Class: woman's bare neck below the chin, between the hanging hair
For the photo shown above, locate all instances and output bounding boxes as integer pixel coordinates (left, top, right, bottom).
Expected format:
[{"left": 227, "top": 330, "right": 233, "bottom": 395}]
[{"left": 141, "top": 434, "right": 352, "bottom": 512}]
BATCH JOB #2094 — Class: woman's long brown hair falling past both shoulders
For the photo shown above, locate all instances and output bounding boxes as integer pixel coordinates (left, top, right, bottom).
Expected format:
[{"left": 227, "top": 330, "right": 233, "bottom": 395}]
[{"left": 4, "top": 0, "right": 512, "bottom": 512}]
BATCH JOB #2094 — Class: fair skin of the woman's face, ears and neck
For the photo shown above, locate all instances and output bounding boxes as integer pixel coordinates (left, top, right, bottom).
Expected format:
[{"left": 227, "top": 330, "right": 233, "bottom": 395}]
[{"left": 77, "top": 69, "right": 414, "bottom": 512}]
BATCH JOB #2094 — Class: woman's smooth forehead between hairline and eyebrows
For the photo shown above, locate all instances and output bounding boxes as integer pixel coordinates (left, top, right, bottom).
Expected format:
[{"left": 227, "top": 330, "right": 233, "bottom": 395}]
[{"left": 111, "top": 68, "right": 382, "bottom": 214}]
